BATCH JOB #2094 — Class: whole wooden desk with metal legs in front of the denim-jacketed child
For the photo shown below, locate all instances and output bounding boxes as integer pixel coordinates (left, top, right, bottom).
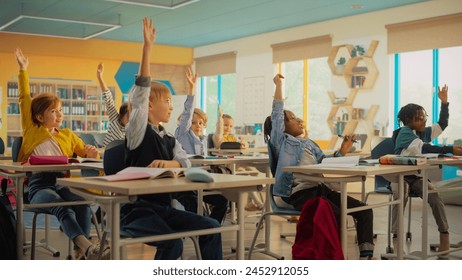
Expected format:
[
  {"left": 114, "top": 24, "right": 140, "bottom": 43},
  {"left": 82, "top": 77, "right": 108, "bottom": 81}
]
[{"left": 283, "top": 165, "right": 436, "bottom": 259}]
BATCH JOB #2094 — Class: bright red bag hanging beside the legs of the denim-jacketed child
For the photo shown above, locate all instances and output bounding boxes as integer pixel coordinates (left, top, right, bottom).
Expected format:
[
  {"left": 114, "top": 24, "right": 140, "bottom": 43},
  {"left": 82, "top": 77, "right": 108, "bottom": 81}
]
[{"left": 292, "top": 197, "right": 345, "bottom": 260}]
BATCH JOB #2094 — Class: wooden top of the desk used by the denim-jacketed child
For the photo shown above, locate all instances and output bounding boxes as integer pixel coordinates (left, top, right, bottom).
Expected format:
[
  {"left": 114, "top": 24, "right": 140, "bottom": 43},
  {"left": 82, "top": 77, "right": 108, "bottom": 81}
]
[{"left": 283, "top": 164, "right": 437, "bottom": 176}]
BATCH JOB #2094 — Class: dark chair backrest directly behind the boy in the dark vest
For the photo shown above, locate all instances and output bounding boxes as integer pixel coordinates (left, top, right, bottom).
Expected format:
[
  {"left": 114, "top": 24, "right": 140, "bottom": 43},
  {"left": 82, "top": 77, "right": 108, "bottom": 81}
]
[{"left": 103, "top": 140, "right": 126, "bottom": 175}]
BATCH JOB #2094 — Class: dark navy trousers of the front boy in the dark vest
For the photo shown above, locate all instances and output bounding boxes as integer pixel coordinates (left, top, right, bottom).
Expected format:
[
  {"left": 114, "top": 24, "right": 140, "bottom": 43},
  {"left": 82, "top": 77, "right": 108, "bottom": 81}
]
[{"left": 120, "top": 199, "right": 223, "bottom": 260}]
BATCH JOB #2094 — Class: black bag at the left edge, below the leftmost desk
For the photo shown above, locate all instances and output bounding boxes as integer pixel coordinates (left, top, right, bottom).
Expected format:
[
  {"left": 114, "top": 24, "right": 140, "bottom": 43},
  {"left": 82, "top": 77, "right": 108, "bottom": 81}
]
[{"left": 0, "top": 179, "right": 18, "bottom": 260}]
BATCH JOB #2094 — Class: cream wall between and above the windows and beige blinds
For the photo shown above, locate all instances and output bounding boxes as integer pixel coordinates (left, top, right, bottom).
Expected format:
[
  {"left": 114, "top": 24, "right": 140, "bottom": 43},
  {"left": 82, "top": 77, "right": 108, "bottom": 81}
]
[{"left": 194, "top": 0, "right": 462, "bottom": 139}]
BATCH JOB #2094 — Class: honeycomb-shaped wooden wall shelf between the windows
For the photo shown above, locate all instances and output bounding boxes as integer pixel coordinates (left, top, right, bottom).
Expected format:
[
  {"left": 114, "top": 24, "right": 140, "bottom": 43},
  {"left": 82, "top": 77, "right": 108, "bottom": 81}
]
[{"left": 327, "top": 40, "right": 379, "bottom": 152}]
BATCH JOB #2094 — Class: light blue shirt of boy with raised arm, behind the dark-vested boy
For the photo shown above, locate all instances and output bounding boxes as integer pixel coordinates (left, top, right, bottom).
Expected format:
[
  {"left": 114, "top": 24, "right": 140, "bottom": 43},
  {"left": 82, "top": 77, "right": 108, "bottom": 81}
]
[{"left": 175, "top": 95, "right": 207, "bottom": 156}]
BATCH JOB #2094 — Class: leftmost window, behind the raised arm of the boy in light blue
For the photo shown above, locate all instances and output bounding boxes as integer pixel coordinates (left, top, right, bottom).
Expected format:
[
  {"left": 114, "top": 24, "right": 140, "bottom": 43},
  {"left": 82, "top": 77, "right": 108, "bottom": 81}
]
[{"left": 196, "top": 74, "right": 236, "bottom": 134}]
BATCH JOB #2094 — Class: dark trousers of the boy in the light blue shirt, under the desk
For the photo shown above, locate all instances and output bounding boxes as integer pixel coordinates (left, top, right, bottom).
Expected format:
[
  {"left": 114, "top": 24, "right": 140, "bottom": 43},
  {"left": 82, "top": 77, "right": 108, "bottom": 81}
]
[{"left": 175, "top": 192, "right": 228, "bottom": 224}]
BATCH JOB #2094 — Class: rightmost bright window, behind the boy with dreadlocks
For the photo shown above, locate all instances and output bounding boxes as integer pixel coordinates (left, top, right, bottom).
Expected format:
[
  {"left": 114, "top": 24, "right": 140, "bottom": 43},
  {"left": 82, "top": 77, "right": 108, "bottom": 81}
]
[{"left": 394, "top": 47, "right": 462, "bottom": 144}]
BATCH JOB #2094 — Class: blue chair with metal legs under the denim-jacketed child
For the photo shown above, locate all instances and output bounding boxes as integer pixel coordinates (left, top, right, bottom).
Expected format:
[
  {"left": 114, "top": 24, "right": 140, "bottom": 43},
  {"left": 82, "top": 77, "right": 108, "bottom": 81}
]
[{"left": 248, "top": 142, "right": 300, "bottom": 260}]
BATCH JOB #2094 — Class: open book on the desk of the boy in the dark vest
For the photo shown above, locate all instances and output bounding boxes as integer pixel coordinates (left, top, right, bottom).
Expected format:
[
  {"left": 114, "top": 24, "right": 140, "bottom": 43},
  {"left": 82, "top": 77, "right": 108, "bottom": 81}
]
[{"left": 93, "top": 167, "right": 186, "bottom": 182}]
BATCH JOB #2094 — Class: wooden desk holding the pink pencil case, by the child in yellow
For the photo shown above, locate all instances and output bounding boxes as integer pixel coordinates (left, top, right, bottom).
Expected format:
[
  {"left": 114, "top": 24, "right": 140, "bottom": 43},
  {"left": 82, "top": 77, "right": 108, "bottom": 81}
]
[{"left": 0, "top": 160, "right": 102, "bottom": 257}]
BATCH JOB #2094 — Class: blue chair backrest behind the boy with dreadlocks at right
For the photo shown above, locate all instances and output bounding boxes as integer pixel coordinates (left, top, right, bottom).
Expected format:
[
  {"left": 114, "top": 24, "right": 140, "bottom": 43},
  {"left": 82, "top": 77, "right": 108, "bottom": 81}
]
[{"left": 371, "top": 136, "right": 395, "bottom": 193}]
